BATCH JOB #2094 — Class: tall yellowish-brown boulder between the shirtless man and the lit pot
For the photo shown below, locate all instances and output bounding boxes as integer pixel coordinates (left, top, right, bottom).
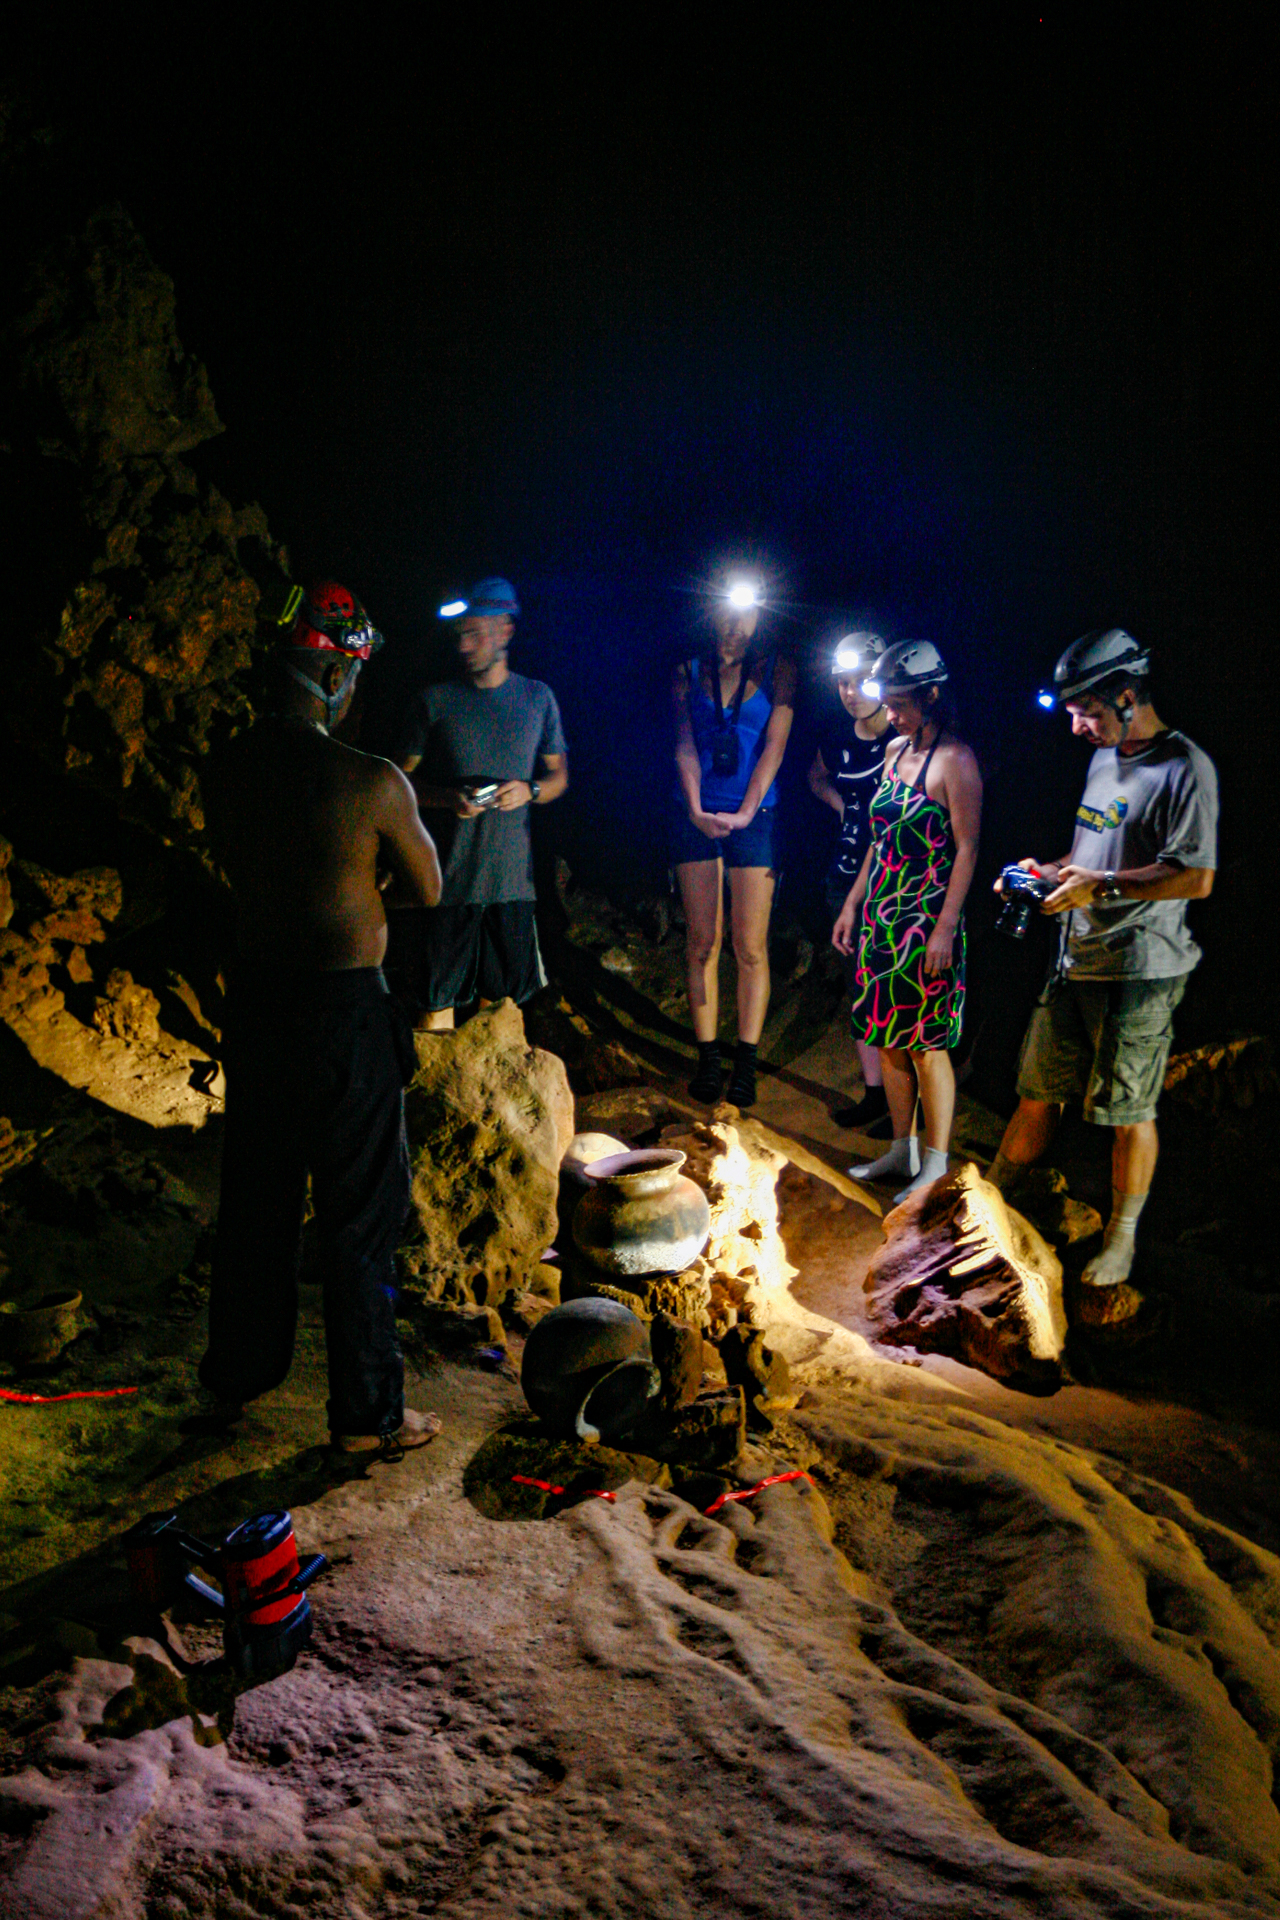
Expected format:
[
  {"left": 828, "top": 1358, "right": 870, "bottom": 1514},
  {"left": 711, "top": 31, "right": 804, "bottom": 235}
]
[{"left": 401, "top": 1000, "right": 574, "bottom": 1306}]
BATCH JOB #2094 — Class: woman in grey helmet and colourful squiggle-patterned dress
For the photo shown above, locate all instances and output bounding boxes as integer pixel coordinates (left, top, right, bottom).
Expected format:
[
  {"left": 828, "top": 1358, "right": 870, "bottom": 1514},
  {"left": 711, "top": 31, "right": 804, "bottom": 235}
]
[{"left": 831, "top": 639, "right": 983, "bottom": 1198}]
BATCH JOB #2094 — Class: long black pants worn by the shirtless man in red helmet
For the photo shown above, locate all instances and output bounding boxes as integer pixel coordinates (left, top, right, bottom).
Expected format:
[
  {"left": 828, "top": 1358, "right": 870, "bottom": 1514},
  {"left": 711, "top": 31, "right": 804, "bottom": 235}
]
[{"left": 200, "top": 968, "right": 413, "bottom": 1434}]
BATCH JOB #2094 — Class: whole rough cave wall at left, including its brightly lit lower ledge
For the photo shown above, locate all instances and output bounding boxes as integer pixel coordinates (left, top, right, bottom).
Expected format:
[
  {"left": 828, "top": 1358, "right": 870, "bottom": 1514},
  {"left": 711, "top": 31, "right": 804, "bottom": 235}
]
[{"left": 0, "top": 207, "right": 286, "bottom": 1125}]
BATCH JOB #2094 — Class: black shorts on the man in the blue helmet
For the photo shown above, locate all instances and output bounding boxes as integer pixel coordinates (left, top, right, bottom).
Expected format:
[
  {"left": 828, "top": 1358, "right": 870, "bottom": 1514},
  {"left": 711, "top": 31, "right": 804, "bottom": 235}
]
[{"left": 391, "top": 900, "right": 547, "bottom": 1014}]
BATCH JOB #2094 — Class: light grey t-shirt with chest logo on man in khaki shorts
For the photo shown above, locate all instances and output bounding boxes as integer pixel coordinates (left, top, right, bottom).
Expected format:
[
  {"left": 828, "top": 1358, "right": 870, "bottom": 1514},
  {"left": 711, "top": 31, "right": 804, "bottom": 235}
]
[{"left": 1067, "top": 730, "right": 1219, "bottom": 979}]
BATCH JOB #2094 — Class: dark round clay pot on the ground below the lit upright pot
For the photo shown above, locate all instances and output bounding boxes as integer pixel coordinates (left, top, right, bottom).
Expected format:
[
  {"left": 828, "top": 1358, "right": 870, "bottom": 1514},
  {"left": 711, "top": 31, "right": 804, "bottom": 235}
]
[{"left": 520, "top": 1300, "right": 662, "bottom": 1440}]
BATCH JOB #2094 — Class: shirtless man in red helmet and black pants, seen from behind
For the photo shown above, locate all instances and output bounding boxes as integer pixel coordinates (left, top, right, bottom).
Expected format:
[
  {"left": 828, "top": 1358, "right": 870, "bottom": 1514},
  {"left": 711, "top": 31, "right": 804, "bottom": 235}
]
[{"left": 200, "top": 582, "right": 439, "bottom": 1457}]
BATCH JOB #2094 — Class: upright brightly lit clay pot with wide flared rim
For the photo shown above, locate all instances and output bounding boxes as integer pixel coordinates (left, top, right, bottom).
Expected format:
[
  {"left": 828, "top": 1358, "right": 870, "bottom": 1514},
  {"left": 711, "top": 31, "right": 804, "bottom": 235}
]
[{"left": 574, "top": 1146, "right": 712, "bottom": 1275}]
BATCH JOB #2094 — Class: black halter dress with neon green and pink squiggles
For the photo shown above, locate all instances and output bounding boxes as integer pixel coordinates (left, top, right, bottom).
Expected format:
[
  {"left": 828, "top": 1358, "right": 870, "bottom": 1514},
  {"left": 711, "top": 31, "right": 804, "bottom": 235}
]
[{"left": 852, "top": 739, "right": 965, "bottom": 1052}]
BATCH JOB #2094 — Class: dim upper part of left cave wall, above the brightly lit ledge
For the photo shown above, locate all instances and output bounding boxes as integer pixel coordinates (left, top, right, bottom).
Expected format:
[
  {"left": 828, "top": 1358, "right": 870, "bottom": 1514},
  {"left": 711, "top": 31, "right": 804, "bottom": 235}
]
[{"left": 8, "top": 207, "right": 286, "bottom": 845}]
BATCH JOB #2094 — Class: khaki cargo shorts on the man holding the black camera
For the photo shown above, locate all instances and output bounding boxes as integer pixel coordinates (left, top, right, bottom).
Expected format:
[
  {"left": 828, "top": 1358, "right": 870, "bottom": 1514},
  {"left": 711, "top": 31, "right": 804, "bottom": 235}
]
[{"left": 1017, "top": 973, "right": 1186, "bottom": 1127}]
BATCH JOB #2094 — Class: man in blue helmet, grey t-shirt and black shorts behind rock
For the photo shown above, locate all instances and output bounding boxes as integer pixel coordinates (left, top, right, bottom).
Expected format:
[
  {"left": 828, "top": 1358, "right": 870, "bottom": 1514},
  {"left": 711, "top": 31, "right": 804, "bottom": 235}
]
[{"left": 399, "top": 578, "right": 568, "bottom": 1031}]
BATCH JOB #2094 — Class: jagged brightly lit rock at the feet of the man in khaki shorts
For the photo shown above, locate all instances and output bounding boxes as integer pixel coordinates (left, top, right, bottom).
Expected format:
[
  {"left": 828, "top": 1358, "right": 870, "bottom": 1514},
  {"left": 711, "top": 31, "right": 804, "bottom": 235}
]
[{"left": 864, "top": 1164, "right": 1067, "bottom": 1394}]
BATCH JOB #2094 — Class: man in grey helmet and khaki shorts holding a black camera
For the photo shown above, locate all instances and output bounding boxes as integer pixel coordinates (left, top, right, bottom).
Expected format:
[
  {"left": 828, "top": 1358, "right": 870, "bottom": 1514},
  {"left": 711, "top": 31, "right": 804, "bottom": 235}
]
[{"left": 988, "top": 628, "right": 1219, "bottom": 1325}]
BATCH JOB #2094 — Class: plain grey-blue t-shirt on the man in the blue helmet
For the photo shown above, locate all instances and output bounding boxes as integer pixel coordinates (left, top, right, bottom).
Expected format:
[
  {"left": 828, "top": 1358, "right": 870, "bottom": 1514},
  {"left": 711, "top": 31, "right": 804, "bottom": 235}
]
[{"left": 405, "top": 674, "right": 564, "bottom": 906}]
